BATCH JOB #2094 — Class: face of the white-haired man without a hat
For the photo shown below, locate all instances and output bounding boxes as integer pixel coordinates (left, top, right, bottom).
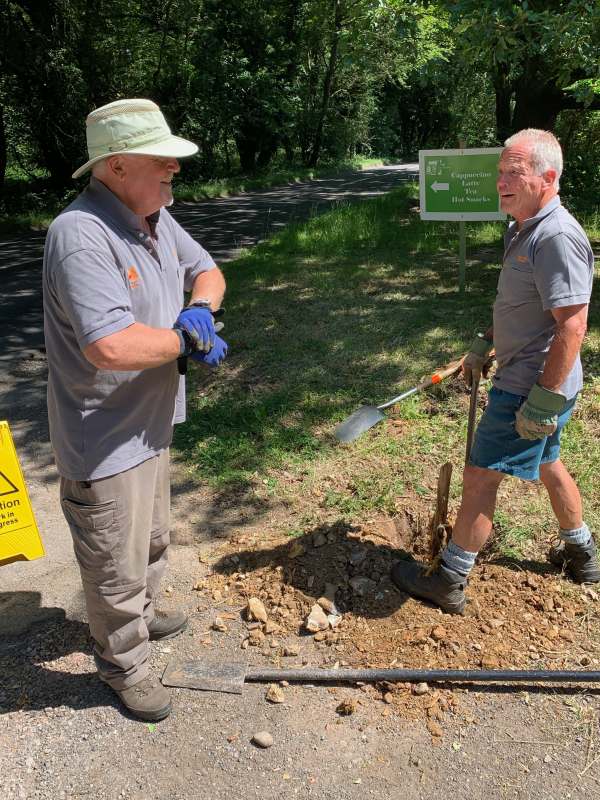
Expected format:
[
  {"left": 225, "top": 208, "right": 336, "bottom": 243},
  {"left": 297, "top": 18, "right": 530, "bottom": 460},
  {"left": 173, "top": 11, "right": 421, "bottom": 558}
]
[{"left": 496, "top": 140, "right": 556, "bottom": 224}]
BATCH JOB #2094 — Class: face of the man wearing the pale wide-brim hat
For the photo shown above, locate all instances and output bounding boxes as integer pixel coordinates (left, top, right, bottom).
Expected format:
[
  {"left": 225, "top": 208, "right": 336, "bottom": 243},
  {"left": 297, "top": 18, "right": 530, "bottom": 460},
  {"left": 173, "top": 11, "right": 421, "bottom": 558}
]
[{"left": 119, "top": 155, "right": 180, "bottom": 217}]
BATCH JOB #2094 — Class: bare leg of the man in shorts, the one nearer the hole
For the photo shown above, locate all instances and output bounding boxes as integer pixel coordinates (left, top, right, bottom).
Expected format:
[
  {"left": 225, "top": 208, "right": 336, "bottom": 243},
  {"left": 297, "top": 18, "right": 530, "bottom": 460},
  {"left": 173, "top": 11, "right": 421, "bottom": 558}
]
[{"left": 452, "top": 466, "right": 504, "bottom": 553}]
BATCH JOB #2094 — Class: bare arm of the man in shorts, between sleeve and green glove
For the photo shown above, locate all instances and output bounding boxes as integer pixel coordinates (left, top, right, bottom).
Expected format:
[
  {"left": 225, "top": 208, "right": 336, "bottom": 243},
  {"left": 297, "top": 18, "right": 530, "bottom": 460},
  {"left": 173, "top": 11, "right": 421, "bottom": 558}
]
[{"left": 538, "top": 303, "right": 588, "bottom": 392}]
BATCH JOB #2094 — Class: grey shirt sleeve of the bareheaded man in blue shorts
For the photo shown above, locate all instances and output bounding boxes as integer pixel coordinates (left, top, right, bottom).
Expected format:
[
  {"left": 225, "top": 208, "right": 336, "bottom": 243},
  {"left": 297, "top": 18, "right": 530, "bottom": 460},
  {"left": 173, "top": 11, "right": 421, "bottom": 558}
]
[{"left": 534, "top": 231, "right": 593, "bottom": 311}]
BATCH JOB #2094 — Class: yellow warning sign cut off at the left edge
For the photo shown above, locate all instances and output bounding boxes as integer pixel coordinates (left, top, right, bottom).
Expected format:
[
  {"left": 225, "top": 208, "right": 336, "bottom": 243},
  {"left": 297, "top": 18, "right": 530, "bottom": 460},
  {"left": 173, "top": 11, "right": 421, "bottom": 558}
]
[{"left": 0, "top": 422, "right": 45, "bottom": 566}]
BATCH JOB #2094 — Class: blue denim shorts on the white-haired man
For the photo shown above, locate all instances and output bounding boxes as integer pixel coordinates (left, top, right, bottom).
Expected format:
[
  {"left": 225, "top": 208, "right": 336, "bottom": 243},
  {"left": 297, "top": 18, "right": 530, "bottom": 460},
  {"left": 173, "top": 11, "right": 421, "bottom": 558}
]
[{"left": 469, "top": 387, "right": 577, "bottom": 481}]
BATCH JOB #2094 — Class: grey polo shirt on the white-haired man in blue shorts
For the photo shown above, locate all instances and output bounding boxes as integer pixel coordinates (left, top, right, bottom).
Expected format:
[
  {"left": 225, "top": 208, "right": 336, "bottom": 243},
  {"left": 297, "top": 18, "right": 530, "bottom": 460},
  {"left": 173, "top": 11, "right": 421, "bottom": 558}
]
[{"left": 493, "top": 197, "right": 594, "bottom": 399}]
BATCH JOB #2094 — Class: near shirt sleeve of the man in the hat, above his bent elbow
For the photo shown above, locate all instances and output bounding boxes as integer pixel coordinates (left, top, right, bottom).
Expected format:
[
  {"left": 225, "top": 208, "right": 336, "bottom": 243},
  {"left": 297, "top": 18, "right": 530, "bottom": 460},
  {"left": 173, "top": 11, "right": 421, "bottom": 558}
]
[{"left": 52, "top": 250, "right": 135, "bottom": 350}]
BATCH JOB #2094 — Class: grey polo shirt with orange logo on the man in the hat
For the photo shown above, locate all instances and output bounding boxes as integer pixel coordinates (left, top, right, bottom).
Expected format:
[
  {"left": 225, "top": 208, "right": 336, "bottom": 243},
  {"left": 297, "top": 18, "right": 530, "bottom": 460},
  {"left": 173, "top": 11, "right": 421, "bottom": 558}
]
[{"left": 42, "top": 177, "right": 215, "bottom": 480}]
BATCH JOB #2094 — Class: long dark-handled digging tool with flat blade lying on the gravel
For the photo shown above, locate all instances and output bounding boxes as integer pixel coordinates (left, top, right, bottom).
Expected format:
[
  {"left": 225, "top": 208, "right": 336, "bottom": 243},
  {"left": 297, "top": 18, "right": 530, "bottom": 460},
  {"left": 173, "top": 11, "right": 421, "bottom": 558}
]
[{"left": 162, "top": 657, "right": 600, "bottom": 694}]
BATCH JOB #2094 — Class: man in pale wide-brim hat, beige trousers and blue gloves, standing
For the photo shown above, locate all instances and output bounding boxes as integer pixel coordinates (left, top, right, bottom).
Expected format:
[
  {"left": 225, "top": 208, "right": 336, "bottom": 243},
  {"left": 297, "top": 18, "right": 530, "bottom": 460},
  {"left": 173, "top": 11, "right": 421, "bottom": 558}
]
[{"left": 43, "top": 99, "right": 227, "bottom": 720}]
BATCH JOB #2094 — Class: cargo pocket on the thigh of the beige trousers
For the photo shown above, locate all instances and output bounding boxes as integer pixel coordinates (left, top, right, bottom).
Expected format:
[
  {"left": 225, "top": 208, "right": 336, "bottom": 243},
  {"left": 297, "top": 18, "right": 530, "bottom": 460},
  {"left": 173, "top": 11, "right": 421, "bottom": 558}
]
[{"left": 61, "top": 497, "right": 119, "bottom": 585}]
